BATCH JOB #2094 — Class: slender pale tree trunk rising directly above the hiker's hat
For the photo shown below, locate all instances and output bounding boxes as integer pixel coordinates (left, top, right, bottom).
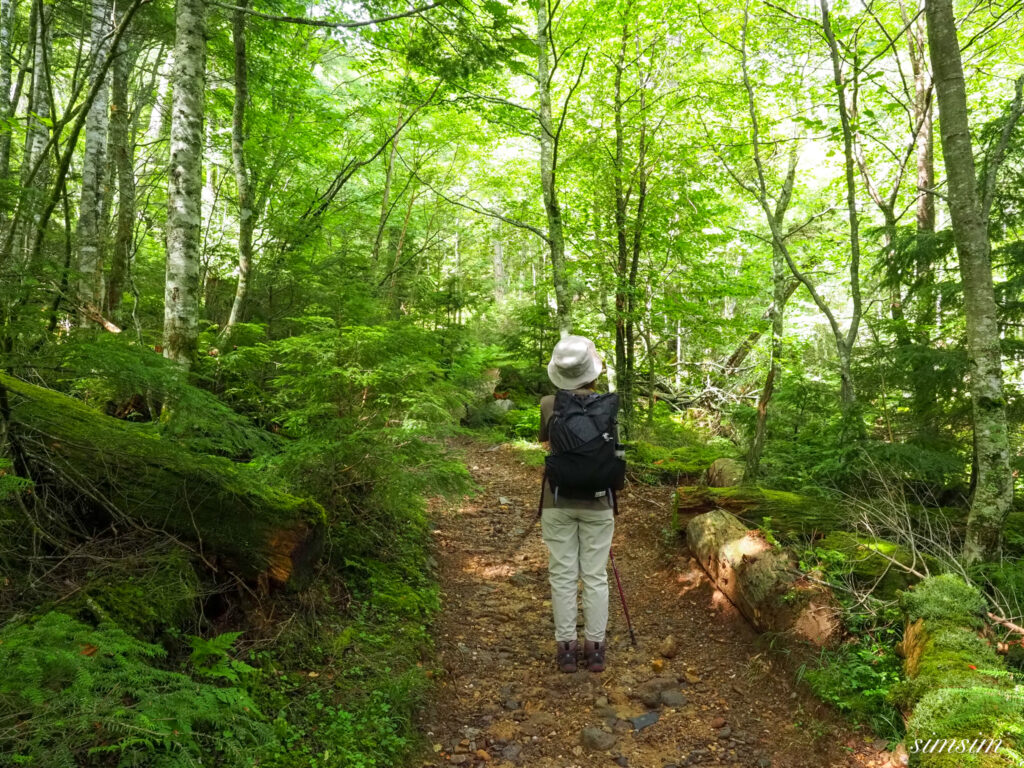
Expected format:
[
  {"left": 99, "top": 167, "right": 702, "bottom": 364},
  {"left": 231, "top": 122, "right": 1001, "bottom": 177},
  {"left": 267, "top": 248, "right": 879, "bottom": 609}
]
[{"left": 537, "top": 0, "right": 572, "bottom": 336}]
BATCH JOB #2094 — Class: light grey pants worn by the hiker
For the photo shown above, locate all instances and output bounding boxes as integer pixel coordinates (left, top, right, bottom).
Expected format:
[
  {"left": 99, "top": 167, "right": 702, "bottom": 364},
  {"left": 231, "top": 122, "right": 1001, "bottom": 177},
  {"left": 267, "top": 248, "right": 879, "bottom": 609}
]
[{"left": 541, "top": 507, "right": 615, "bottom": 642}]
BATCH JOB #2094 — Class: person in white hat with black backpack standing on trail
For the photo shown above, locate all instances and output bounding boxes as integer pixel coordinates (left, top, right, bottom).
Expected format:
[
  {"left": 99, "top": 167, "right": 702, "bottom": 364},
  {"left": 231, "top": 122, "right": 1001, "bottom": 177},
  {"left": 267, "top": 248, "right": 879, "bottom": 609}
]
[{"left": 541, "top": 336, "right": 626, "bottom": 672}]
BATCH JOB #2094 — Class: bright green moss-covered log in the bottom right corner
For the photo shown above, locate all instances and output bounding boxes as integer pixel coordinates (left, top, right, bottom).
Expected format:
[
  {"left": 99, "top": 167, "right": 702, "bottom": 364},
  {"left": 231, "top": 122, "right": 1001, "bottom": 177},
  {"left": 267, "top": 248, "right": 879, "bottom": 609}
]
[{"left": 893, "top": 573, "right": 1024, "bottom": 768}]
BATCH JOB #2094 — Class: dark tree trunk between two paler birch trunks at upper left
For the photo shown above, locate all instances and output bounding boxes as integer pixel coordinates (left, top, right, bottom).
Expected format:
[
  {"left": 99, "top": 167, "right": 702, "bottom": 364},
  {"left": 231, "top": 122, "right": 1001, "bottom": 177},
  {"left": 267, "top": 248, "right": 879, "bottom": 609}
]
[{"left": 106, "top": 35, "right": 136, "bottom": 315}]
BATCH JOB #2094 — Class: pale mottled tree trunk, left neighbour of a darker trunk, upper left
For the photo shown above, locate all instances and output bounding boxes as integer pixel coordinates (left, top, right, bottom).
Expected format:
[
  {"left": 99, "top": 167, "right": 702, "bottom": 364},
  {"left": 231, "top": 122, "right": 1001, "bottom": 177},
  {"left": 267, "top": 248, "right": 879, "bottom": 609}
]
[{"left": 78, "top": 0, "right": 114, "bottom": 315}]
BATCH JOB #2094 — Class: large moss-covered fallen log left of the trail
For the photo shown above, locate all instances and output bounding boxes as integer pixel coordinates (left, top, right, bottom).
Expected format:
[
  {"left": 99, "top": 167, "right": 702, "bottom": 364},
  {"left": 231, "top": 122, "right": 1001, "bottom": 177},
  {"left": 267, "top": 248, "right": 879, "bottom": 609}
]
[{"left": 0, "top": 374, "right": 325, "bottom": 586}]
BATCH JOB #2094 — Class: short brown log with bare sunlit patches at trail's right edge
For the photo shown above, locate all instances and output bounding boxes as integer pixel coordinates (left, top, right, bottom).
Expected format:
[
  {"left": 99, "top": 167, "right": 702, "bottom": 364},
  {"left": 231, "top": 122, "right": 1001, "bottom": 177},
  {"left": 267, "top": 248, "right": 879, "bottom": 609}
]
[{"left": 686, "top": 510, "right": 841, "bottom": 646}]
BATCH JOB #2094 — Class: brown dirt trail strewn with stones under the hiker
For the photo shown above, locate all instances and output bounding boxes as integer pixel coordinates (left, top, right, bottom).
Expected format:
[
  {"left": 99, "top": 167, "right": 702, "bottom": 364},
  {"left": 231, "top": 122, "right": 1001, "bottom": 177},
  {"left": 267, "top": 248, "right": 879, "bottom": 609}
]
[{"left": 422, "top": 443, "right": 888, "bottom": 768}]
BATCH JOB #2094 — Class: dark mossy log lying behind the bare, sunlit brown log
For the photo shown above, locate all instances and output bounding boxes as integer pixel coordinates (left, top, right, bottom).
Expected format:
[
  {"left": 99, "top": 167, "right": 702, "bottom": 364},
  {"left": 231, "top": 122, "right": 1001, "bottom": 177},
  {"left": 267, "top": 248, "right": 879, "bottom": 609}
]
[{"left": 676, "top": 485, "right": 842, "bottom": 538}]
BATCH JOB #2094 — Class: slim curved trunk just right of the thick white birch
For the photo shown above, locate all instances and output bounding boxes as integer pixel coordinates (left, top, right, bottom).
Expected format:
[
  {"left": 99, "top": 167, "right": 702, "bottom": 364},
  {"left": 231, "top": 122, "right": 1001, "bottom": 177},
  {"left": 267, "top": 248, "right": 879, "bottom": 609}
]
[{"left": 221, "top": 0, "right": 249, "bottom": 338}]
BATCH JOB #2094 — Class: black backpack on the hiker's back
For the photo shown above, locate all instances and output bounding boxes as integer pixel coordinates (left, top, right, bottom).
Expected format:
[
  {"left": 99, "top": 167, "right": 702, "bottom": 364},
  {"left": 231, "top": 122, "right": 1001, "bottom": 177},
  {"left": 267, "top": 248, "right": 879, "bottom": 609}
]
[{"left": 544, "top": 389, "right": 626, "bottom": 499}]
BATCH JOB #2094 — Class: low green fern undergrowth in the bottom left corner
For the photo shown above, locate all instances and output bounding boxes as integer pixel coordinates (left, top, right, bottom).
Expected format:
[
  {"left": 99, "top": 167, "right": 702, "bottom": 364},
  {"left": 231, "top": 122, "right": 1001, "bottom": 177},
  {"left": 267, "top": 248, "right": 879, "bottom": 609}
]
[{"left": 0, "top": 611, "right": 274, "bottom": 768}]
